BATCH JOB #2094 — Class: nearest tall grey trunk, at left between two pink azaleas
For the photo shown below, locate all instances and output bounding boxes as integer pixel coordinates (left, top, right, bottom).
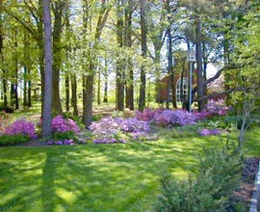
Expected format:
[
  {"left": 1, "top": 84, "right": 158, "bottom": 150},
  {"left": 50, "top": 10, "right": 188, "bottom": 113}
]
[{"left": 42, "top": 0, "right": 52, "bottom": 137}]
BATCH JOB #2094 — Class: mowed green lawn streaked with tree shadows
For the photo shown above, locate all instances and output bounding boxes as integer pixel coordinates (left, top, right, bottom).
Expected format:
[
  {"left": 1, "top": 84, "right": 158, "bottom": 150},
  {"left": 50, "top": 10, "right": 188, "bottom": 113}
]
[{"left": 0, "top": 129, "right": 260, "bottom": 212}]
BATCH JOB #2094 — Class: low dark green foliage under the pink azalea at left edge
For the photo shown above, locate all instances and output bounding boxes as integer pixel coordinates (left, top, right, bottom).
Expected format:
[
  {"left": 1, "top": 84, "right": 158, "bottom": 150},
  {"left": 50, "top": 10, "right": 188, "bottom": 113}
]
[{"left": 0, "top": 134, "right": 30, "bottom": 146}]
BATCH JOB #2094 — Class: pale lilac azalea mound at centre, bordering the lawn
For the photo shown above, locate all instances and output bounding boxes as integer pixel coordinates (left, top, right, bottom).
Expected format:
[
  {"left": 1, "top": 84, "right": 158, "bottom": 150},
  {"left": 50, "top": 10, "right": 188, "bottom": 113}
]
[{"left": 89, "top": 116, "right": 150, "bottom": 143}]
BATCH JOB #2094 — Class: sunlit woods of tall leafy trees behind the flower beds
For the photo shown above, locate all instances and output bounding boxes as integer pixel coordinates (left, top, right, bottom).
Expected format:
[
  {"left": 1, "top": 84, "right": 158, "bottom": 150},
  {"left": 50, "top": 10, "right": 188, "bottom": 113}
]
[{"left": 0, "top": 0, "right": 260, "bottom": 132}]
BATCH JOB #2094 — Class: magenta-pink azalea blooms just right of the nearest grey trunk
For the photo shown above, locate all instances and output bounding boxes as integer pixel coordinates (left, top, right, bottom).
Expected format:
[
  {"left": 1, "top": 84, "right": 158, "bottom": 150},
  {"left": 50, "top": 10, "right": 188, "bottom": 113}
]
[{"left": 51, "top": 115, "right": 80, "bottom": 133}]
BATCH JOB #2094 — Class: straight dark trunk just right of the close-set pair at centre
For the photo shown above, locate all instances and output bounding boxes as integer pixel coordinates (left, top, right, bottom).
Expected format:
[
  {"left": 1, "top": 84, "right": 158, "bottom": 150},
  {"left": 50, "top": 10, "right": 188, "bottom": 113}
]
[{"left": 139, "top": 0, "right": 147, "bottom": 111}]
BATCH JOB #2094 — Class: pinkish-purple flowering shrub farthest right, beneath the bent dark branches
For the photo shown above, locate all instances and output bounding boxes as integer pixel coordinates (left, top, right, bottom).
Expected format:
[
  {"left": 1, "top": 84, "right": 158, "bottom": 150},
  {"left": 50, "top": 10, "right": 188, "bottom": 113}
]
[{"left": 206, "top": 99, "right": 230, "bottom": 116}]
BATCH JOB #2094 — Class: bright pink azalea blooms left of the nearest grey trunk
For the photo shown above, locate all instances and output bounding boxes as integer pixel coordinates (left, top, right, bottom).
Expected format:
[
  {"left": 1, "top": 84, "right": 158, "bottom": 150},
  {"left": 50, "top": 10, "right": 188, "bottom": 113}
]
[{"left": 5, "top": 119, "right": 37, "bottom": 138}]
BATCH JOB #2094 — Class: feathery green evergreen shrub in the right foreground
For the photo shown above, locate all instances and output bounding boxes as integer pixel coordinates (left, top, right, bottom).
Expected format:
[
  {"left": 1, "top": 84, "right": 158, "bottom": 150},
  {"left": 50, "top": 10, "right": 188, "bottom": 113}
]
[{"left": 156, "top": 145, "right": 242, "bottom": 212}]
